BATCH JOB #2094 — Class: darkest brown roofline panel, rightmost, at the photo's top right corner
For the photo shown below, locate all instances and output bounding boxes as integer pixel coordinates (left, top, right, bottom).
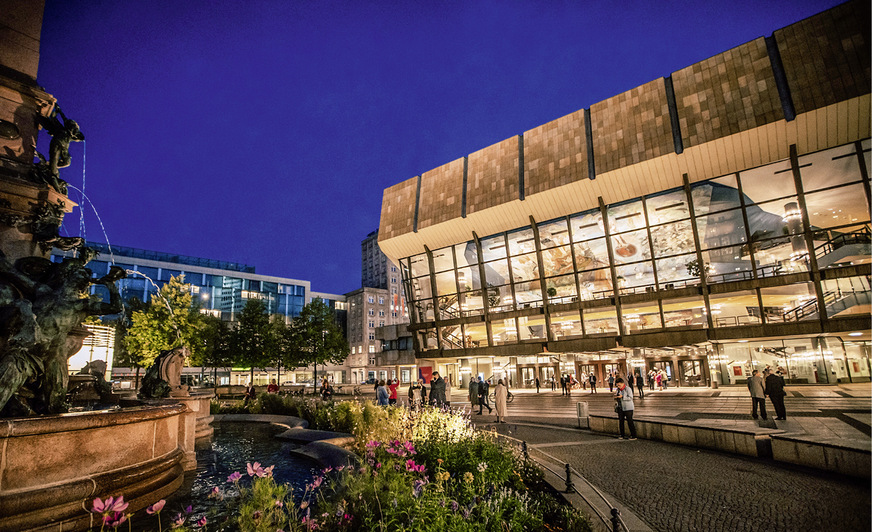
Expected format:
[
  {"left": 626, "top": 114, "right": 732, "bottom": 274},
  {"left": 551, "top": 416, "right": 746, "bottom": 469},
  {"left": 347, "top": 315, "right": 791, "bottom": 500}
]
[{"left": 774, "top": 0, "right": 872, "bottom": 114}]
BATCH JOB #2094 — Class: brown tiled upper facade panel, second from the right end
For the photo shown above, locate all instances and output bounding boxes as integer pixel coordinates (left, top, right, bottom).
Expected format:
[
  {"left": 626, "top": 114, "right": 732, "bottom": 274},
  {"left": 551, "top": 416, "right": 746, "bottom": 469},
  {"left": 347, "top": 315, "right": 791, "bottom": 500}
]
[{"left": 672, "top": 37, "right": 784, "bottom": 147}]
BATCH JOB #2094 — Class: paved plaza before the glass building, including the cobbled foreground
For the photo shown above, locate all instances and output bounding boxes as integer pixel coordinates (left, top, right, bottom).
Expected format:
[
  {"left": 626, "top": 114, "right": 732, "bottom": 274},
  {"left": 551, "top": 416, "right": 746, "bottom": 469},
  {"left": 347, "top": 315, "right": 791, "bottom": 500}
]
[{"left": 452, "top": 384, "right": 872, "bottom": 531}]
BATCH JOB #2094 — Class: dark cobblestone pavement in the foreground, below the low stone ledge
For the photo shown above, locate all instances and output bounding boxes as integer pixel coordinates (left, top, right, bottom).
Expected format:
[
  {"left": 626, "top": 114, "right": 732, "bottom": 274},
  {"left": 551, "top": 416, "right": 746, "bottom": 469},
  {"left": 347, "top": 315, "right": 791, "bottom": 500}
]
[{"left": 493, "top": 423, "right": 872, "bottom": 532}]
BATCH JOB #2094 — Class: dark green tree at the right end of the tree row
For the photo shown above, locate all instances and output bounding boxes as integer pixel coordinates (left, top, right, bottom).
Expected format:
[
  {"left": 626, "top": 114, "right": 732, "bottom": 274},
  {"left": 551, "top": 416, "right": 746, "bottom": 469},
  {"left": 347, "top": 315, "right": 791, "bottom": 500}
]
[{"left": 285, "top": 299, "right": 348, "bottom": 390}]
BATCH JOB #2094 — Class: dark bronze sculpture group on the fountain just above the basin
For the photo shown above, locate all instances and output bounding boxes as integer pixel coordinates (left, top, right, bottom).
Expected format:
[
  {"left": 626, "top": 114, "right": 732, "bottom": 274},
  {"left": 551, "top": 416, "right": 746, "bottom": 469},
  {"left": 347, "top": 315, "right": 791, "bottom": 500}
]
[{"left": 0, "top": 252, "right": 126, "bottom": 416}]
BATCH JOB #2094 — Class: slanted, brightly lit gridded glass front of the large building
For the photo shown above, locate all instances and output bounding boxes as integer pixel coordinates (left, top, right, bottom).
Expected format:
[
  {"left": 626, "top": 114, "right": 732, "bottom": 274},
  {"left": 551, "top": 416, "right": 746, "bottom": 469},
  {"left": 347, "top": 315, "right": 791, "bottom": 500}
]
[{"left": 401, "top": 140, "right": 872, "bottom": 383}]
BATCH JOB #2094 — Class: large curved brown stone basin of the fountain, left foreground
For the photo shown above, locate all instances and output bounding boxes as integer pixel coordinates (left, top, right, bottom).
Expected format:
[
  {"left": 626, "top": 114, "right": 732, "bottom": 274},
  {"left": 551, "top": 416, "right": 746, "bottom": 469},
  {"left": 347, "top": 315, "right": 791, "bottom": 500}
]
[{"left": 0, "top": 402, "right": 190, "bottom": 531}]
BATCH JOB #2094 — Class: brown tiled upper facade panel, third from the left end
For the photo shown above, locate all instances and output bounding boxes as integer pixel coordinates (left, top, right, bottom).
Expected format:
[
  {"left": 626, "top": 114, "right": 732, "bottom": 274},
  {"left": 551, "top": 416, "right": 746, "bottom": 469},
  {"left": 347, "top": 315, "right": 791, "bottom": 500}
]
[{"left": 466, "top": 137, "right": 519, "bottom": 214}]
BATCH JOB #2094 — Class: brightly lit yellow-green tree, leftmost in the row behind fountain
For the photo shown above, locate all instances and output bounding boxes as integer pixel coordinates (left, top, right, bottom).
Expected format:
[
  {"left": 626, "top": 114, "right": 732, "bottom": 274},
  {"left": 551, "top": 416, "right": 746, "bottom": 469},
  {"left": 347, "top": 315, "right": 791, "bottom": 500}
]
[{"left": 124, "top": 276, "right": 205, "bottom": 368}]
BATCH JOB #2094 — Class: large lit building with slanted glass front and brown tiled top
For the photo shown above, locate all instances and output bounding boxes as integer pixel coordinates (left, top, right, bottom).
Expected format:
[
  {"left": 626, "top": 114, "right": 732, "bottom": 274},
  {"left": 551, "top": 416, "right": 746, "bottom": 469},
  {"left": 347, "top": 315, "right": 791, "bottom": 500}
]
[{"left": 379, "top": 2, "right": 872, "bottom": 386}]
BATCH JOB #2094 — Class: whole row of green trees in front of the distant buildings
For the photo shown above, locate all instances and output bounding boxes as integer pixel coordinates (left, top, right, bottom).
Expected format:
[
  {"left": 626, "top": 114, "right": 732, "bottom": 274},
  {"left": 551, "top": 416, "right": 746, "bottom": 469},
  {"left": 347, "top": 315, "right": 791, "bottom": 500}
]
[{"left": 114, "top": 276, "right": 348, "bottom": 384}]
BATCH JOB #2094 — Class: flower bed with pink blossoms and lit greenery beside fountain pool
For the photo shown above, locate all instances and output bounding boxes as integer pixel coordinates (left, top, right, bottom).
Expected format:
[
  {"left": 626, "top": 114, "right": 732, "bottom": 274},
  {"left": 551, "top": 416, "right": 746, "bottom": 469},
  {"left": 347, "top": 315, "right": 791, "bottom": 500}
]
[{"left": 88, "top": 395, "right": 590, "bottom": 532}]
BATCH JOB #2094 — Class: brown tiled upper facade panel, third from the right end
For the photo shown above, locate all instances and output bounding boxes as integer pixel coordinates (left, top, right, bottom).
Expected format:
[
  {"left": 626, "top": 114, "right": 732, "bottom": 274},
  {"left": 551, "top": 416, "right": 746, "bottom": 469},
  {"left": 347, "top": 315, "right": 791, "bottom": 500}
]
[{"left": 590, "top": 79, "right": 675, "bottom": 174}]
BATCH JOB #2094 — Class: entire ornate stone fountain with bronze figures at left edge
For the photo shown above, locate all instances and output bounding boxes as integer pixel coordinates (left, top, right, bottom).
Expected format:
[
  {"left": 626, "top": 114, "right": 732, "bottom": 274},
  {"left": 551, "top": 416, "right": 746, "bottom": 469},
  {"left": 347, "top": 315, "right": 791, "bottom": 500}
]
[{"left": 0, "top": 0, "right": 211, "bottom": 531}]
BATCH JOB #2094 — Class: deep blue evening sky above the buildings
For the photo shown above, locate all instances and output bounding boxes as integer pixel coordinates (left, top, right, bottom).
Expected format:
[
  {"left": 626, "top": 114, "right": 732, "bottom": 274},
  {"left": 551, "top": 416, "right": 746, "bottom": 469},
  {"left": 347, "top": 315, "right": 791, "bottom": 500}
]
[{"left": 37, "top": 0, "right": 839, "bottom": 293}]
